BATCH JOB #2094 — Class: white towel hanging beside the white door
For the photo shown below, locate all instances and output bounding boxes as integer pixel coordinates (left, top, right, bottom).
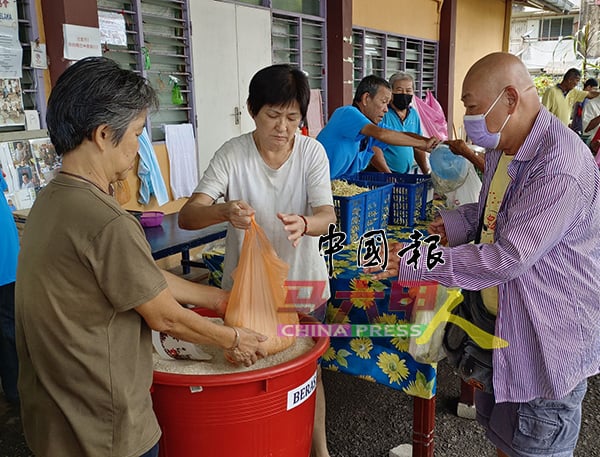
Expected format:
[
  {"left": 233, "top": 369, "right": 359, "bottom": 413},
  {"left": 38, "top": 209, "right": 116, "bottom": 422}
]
[{"left": 165, "top": 124, "right": 198, "bottom": 199}]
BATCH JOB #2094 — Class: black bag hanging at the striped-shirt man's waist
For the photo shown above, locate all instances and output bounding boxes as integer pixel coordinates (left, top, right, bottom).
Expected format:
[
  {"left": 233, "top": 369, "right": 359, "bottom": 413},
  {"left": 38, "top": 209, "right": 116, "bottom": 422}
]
[{"left": 442, "top": 290, "right": 496, "bottom": 393}]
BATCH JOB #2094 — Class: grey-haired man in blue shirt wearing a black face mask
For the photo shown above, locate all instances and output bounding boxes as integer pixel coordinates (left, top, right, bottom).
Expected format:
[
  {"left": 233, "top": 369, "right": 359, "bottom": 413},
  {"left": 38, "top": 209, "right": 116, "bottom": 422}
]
[{"left": 383, "top": 72, "right": 430, "bottom": 174}]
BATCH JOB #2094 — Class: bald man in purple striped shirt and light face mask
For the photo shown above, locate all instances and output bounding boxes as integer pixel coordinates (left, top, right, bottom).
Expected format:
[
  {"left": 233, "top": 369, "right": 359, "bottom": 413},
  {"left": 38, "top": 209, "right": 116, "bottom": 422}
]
[{"left": 377, "top": 53, "right": 600, "bottom": 457}]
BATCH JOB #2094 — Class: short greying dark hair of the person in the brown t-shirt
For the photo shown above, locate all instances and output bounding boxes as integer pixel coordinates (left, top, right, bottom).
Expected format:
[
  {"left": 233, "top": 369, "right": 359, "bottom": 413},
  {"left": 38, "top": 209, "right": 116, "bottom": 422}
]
[{"left": 46, "top": 57, "right": 158, "bottom": 155}]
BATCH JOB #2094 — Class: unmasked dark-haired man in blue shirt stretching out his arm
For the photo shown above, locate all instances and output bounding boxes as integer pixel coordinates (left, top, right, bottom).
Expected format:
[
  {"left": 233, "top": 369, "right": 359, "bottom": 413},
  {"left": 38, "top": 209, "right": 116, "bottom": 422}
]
[{"left": 317, "top": 75, "right": 439, "bottom": 179}]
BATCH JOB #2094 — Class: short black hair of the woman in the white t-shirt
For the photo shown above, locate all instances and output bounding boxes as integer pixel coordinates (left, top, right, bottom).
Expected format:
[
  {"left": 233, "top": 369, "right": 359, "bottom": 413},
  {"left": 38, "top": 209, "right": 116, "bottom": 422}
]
[{"left": 248, "top": 64, "right": 310, "bottom": 119}]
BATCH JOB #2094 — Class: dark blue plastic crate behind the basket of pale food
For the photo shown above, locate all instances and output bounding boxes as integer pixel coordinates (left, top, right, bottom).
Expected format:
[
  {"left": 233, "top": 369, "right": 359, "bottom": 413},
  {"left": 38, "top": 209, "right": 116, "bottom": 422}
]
[{"left": 349, "top": 172, "right": 433, "bottom": 227}]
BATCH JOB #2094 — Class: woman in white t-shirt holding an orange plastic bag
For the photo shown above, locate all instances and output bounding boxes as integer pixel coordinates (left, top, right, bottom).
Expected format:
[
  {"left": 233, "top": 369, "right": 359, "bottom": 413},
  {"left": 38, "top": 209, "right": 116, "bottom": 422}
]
[{"left": 179, "top": 65, "right": 336, "bottom": 457}]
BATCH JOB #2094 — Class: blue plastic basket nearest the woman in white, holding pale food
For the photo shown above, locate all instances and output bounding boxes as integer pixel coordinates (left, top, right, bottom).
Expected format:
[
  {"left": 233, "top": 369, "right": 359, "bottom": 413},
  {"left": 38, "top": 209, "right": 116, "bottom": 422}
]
[{"left": 333, "top": 178, "right": 394, "bottom": 244}]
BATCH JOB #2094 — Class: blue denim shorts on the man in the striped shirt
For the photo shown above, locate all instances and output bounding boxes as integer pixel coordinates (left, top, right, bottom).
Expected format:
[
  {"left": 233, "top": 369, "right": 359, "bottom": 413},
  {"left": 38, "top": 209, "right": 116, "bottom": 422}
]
[{"left": 475, "top": 379, "right": 587, "bottom": 457}]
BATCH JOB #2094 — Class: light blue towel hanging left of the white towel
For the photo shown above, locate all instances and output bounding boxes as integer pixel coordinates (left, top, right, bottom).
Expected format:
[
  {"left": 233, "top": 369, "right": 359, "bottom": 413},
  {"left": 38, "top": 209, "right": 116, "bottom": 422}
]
[{"left": 138, "top": 127, "right": 169, "bottom": 205}]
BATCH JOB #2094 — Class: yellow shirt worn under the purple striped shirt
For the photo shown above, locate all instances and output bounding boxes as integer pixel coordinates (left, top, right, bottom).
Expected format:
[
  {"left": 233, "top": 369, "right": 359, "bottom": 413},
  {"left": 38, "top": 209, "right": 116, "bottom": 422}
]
[{"left": 481, "top": 154, "right": 514, "bottom": 316}]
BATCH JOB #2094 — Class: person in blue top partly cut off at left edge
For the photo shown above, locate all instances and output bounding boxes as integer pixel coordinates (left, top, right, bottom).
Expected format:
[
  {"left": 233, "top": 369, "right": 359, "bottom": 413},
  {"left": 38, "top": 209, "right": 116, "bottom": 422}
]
[{"left": 0, "top": 172, "right": 19, "bottom": 404}]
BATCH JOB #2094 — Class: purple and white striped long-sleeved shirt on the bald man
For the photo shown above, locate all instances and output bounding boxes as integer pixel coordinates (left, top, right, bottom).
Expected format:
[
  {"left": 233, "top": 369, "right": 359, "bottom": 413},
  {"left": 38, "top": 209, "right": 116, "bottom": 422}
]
[{"left": 399, "top": 107, "right": 600, "bottom": 402}]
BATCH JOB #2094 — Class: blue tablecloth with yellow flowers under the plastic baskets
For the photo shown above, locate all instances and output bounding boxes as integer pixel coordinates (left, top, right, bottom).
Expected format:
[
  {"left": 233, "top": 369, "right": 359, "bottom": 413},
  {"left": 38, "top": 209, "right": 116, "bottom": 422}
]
[{"left": 203, "top": 226, "right": 436, "bottom": 399}]
